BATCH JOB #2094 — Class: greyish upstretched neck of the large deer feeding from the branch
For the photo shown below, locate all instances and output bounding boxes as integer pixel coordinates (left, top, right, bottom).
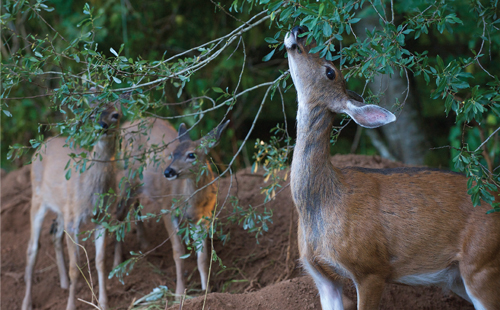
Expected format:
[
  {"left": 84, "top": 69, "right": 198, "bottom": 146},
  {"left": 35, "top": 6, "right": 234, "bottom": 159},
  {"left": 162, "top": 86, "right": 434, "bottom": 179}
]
[{"left": 291, "top": 101, "right": 343, "bottom": 232}]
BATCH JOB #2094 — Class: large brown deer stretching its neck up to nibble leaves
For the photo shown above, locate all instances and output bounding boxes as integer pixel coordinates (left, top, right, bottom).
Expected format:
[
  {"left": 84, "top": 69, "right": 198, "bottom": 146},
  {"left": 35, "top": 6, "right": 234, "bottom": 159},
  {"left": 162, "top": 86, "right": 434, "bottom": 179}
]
[{"left": 285, "top": 27, "right": 500, "bottom": 310}]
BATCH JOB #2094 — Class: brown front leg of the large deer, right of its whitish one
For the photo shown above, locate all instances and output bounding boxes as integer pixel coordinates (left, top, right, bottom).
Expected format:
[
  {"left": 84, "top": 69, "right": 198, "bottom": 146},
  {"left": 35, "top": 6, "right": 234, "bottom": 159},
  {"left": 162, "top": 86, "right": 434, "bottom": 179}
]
[{"left": 355, "top": 275, "right": 385, "bottom": 310}]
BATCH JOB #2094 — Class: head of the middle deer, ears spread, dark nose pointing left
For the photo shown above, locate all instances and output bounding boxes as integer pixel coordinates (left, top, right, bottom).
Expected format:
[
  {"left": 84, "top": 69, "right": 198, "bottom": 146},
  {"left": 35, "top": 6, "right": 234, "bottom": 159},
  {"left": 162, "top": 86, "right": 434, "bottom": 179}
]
[{"left": 164, "top": 121, "right": 229, "bottom": 180}]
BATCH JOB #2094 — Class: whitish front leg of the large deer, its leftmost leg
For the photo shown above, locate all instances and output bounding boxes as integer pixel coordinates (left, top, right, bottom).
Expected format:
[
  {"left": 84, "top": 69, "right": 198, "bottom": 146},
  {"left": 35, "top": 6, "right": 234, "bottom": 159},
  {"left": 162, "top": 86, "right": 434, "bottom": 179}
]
[{"left": 304, "top": 261, "right": 344, "bottom": 310}]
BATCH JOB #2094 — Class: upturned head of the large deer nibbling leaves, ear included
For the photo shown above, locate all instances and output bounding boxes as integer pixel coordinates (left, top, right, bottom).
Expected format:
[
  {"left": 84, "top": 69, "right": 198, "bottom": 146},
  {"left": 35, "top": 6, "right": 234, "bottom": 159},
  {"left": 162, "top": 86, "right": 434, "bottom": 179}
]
[{"left": 285, "top": 26, "right": 396, "bottom": 128}]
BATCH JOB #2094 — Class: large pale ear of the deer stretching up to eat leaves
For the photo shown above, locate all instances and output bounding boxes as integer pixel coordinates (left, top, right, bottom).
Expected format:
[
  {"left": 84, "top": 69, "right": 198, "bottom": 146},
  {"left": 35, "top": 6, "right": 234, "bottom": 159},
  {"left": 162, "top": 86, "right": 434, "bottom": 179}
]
[{"left": 340, "top": 99, "right": 396, "bottom": 128}]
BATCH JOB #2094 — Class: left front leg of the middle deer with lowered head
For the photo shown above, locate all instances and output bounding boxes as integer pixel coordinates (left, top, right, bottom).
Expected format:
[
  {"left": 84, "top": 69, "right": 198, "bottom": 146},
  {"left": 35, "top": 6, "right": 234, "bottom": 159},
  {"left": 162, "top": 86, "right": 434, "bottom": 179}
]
[{"left": 163, "top": 215, "right": 186, "bottom": 299}]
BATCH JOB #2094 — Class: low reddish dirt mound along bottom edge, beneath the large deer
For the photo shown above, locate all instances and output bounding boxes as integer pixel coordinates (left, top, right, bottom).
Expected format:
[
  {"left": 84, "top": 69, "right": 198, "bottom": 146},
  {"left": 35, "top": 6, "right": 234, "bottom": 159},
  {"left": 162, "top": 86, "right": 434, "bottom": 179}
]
[{"left": 168, "top": 277, "right": 474, "bottom": 310}]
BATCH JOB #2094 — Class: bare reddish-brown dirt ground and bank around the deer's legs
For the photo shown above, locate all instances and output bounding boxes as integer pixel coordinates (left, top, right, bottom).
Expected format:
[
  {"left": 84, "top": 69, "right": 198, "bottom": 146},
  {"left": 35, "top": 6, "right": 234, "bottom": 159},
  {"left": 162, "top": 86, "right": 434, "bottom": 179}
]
[{"left": 1, "top": 155, "right": 474, "bottom": 310}]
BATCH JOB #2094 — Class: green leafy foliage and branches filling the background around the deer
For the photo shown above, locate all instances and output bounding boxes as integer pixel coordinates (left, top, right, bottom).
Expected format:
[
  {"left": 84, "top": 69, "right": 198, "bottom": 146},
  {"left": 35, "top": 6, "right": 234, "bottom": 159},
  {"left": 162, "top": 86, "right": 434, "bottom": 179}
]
[{"left": 0, "top": 0, "right": 500, "bottom": 294}]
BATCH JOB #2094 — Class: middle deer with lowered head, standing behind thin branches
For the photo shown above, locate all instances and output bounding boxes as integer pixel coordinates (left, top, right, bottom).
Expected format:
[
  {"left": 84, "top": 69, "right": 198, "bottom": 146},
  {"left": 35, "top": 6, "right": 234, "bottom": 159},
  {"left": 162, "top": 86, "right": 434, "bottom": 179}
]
[{"left": 114, "top": 118, "right": 228, "bottom": 299}]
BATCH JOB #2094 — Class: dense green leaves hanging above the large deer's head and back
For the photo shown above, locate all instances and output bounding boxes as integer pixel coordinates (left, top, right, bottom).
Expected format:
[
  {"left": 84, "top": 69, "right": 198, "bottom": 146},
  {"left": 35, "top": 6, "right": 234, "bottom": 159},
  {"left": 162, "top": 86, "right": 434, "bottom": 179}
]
[{"left": 232, "top": 0, "right": 500, "bottom": 211}]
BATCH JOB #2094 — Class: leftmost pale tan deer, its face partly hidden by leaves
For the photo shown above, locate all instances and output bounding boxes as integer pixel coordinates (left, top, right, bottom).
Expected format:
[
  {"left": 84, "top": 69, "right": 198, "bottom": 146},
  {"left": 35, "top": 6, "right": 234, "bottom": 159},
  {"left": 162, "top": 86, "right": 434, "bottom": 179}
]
[{"left": 22, "top": 91, "right": 122, "bottom": 310}]
